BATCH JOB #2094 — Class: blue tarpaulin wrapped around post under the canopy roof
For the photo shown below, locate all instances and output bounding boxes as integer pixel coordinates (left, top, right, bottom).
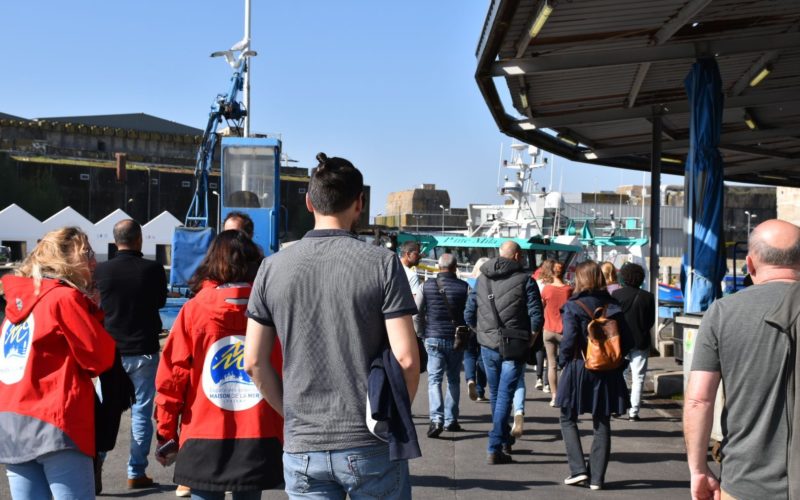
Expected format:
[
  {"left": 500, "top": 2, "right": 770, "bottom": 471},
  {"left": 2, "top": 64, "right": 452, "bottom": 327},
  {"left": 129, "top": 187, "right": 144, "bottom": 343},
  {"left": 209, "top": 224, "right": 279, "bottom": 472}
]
[{"left": 681, "top": 58, "right": 725, "bottom": 312}]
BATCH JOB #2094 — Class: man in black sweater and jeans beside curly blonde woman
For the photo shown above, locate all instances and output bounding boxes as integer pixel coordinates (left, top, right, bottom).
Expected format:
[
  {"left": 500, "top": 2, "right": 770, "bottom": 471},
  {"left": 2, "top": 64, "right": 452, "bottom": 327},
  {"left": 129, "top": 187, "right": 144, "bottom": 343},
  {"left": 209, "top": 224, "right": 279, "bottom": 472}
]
[{"left": 95, "top": 219, "right": 167, "bottom": 489}]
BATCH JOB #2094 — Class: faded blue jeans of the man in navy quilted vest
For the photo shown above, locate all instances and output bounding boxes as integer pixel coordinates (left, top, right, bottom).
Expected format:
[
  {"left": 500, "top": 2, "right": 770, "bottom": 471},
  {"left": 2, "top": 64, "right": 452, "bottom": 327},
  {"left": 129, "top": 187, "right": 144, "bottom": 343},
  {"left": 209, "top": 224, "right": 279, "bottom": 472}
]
[{"left": 425, "top": 338, "right": 463, "bottom": 425}]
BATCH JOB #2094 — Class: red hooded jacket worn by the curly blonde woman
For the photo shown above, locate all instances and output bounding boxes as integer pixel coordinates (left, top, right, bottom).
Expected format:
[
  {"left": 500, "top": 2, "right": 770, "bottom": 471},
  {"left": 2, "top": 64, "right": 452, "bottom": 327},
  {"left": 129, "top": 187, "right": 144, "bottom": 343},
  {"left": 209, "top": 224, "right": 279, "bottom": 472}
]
[{"left": 0, "top": 276, "right": 115, "bottom": 463}]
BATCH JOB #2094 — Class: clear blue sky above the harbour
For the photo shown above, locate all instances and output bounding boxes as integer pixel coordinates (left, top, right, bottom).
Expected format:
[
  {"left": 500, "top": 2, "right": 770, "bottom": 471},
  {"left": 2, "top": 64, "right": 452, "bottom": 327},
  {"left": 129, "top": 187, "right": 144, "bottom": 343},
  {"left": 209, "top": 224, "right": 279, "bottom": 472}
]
[{"left": 0, "top": 0, "right": 681, "bottom": 215}]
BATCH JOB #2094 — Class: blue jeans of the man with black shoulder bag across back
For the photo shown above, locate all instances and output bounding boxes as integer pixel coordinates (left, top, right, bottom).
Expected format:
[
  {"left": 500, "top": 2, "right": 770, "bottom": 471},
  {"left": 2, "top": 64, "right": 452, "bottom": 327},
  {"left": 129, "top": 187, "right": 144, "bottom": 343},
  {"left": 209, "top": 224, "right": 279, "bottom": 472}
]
[{"left": 481, "top": 347, "right": 525, "bottom": 453}]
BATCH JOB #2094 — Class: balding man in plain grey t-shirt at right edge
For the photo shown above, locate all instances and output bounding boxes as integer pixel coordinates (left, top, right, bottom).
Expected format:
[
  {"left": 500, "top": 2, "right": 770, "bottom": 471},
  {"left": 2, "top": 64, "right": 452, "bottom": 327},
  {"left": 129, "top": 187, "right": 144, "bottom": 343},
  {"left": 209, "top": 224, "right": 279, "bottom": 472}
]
[{"left": 684, "top": 220, "right": 800, "bottom": 499}]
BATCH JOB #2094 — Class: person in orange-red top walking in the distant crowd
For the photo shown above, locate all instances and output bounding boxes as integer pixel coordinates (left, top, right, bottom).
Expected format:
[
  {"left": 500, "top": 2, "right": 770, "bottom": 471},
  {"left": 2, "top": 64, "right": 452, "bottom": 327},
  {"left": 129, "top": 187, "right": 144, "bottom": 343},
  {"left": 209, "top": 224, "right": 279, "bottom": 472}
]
[{"left": 542, "top": 259, "right": 572, "bottom": 406}]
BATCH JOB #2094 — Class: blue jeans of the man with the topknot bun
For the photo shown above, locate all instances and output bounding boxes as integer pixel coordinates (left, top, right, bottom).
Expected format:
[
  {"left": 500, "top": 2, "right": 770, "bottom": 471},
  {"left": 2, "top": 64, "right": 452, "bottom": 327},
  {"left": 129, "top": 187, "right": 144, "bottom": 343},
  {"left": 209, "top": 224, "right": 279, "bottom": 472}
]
[{"left": 283, "top": 444, "right": 411, "bottom": 500}]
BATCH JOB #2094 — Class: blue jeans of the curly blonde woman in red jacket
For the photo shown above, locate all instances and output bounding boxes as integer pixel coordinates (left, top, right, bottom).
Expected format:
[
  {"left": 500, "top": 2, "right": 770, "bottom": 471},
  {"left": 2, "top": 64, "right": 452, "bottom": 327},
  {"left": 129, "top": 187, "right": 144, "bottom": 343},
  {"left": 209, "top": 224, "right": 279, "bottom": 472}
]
[{"left": 6, "top": 450, "right": 94, "bottom": 500}]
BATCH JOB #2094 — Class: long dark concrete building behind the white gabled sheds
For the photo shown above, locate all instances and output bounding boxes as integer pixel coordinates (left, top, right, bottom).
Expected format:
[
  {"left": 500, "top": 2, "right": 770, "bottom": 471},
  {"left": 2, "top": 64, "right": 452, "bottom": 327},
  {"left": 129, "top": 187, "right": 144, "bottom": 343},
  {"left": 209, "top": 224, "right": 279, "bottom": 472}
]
[{"left": 0, "top": 113, "right": 369, "bottom": 260}]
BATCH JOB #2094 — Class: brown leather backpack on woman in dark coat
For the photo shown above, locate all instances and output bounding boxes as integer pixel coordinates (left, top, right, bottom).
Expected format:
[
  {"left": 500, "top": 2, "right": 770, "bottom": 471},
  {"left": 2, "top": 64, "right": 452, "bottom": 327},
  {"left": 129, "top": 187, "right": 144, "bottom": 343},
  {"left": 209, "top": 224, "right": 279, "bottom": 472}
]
[{"left": 575, "top": 300, "right": 623, "bottom": 372}]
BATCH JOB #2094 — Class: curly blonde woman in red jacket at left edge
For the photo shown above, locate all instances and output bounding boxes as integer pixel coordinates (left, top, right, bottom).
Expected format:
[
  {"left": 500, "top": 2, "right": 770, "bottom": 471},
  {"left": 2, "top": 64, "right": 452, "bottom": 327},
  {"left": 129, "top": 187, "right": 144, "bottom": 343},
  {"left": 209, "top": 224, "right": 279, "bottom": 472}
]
[{"left": 0, "top": 227, "right": 115, "bottom": 500}]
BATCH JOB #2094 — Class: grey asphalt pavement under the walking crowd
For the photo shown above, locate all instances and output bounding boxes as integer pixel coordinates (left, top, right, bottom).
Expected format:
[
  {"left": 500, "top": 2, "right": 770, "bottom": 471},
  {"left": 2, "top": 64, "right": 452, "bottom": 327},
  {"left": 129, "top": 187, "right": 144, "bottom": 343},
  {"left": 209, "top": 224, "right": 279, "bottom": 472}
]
[{"left": 0, "top": 358, "right": 689, "bottom": 500}]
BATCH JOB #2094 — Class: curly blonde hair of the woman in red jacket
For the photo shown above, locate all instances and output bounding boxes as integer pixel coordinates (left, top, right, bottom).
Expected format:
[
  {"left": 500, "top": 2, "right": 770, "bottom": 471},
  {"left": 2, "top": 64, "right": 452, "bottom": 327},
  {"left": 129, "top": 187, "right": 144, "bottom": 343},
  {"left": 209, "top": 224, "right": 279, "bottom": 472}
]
[{"left": 16, "top": 227, "right": 92, "bottom": 295}]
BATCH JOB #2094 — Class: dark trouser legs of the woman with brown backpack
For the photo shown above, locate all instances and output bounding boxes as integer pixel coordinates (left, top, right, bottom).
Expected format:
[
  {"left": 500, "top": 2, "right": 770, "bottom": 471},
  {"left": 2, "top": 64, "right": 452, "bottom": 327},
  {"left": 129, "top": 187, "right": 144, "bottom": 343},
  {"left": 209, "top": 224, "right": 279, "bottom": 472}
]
[{"left": 560, "top": 408, "right": 611, "bottom": 486}]
